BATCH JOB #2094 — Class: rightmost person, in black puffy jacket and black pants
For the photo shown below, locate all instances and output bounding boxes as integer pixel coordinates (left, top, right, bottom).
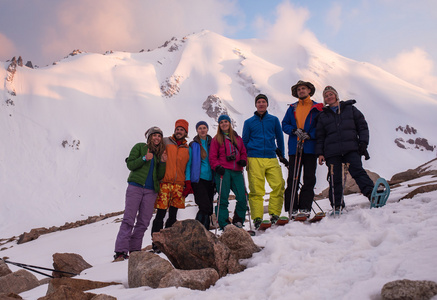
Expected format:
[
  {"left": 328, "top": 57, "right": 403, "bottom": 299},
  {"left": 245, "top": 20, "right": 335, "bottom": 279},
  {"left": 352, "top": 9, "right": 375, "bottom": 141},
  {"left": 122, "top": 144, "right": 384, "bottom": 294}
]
[{"left": 316, "top": 86, "right": 374, "bottom": 214}]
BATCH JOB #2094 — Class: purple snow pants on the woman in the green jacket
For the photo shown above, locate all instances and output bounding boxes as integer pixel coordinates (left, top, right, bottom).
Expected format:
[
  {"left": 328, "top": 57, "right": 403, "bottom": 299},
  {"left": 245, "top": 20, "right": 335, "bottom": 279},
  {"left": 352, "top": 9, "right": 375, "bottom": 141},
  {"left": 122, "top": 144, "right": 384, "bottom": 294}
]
[{"left": 115, "top": 184, "right": 158, "bottom": 253}]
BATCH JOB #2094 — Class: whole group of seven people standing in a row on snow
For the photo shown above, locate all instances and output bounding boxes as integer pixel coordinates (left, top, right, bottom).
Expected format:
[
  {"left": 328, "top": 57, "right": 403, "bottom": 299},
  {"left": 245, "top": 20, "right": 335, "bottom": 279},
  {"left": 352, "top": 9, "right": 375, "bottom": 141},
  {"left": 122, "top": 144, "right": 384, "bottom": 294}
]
[{"left": 110, "top": 80, "right": 373, "bottom": 260}]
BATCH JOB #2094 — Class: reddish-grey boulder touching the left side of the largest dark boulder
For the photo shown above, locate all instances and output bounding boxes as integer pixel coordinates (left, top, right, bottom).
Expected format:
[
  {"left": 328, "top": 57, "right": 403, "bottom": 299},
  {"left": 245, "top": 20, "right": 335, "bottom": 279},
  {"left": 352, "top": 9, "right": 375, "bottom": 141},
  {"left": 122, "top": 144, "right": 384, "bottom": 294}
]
[{"left": 128, "top": 251, "right": 174, "bottom": 288}]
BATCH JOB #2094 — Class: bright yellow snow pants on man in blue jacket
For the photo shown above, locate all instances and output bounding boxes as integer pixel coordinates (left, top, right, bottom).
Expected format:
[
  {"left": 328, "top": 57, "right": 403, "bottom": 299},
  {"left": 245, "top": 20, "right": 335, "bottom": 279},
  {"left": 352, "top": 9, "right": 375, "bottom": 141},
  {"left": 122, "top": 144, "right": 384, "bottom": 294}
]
[{"left": 246, "top": 157, "right": 285, "bottom": 219}]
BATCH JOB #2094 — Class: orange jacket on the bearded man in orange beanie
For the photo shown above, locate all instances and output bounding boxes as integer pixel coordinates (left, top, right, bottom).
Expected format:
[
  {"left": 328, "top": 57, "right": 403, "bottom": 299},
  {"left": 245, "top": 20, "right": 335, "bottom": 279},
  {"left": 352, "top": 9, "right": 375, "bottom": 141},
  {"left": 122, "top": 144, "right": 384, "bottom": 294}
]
[{"left": 161, "top": 136, "right": 190, "bottom": 186}]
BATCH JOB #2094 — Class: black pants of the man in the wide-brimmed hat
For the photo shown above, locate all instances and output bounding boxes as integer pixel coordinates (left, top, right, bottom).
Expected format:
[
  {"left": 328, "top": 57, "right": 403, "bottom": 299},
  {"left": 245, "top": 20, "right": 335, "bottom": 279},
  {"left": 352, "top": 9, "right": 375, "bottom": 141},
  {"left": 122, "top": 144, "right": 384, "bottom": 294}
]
[{"left": 284, "top": 153, "right": 317, "bottom": 211}]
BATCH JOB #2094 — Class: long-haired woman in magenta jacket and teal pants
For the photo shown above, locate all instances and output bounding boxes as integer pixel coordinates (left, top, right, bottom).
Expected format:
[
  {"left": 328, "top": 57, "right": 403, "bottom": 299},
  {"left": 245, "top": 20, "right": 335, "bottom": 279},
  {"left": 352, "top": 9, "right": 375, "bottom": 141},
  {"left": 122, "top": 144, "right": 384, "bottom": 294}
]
[{"left": 209, "top": 115, "right": 247, "bottom": 229}]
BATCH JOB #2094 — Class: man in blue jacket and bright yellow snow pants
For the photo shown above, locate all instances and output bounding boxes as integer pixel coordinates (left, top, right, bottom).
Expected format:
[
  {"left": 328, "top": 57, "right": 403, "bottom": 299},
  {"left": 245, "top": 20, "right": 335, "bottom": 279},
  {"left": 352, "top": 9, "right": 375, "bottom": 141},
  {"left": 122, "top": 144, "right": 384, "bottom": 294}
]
[{"left": 243, "top": 94, "right": 285, "bottom": 228}]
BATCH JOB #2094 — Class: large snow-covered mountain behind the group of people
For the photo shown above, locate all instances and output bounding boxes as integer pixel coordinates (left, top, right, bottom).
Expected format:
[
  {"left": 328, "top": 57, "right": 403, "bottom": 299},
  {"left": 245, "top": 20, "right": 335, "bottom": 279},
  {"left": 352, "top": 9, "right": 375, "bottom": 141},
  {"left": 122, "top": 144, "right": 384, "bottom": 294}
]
[{"left": 0, "top": 31, "right": 437, "bottom": 236}]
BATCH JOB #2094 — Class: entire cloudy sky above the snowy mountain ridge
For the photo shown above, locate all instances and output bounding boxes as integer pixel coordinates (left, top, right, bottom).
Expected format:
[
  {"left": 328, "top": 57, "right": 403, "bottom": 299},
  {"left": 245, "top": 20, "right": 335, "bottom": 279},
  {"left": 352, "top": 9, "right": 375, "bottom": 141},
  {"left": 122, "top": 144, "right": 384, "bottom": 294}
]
[{"left": 0, "top": 0, "right": 437, "bottom": 93}]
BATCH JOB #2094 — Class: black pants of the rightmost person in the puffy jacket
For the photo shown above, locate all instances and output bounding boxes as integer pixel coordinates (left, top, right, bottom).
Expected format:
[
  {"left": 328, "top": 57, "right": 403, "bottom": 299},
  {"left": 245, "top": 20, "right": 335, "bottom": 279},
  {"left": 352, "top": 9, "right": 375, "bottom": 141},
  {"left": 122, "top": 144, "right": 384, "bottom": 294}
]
[{"left": 326, "top": 151, "right": 374, "bottom": 207}]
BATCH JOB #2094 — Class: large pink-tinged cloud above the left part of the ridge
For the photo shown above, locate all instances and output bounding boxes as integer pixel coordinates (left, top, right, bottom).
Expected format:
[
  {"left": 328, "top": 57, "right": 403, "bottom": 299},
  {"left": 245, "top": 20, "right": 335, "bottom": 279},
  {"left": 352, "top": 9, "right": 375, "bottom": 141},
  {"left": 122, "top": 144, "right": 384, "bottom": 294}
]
[{"left": 37, "top": 0, "right": 234, "bottom": 61}]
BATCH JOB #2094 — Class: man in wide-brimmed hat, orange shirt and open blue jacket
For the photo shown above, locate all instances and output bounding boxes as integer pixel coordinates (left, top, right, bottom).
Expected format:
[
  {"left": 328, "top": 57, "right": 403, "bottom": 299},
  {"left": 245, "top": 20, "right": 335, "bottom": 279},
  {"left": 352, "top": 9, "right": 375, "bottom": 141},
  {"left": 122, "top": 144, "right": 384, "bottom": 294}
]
[{"left": 282, "top": 80, "right": 323, "bottom": 218}]
